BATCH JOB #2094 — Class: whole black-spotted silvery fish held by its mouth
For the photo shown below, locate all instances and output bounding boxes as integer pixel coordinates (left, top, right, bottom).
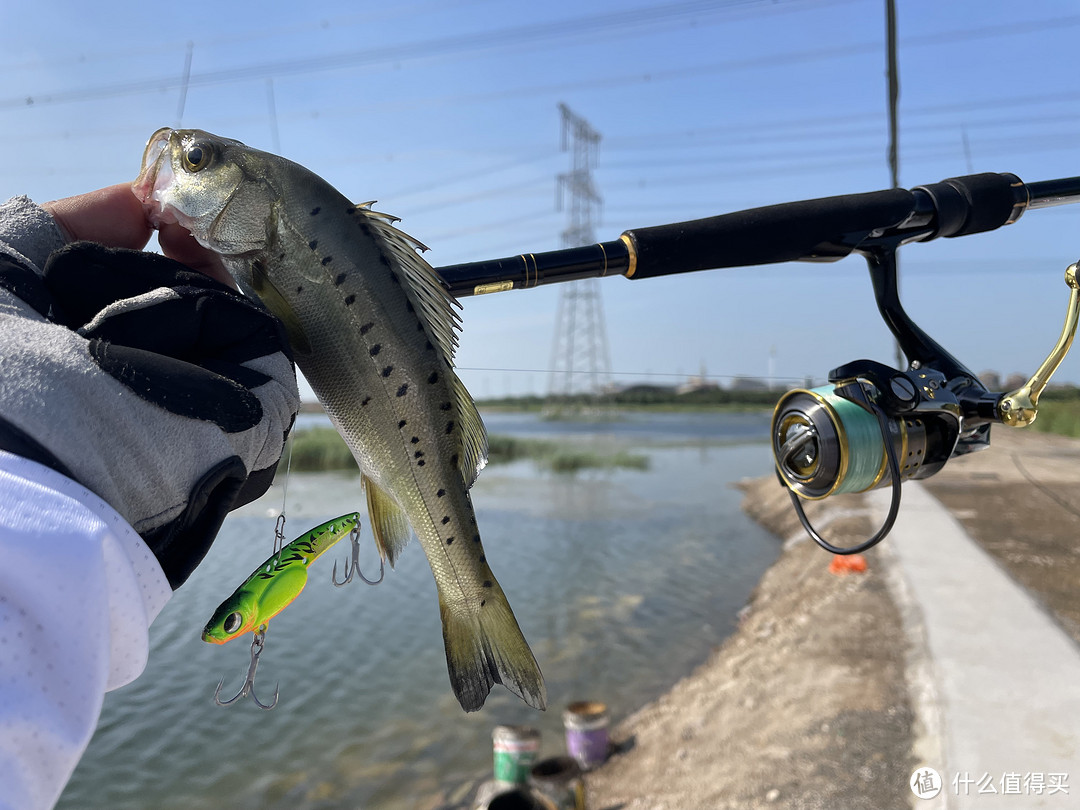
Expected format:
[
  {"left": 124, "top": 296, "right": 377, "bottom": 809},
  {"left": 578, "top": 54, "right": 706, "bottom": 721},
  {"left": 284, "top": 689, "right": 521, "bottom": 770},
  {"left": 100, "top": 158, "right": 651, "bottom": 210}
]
[{"left": 133, "top": 127, "right": 546, "bottom": 712}]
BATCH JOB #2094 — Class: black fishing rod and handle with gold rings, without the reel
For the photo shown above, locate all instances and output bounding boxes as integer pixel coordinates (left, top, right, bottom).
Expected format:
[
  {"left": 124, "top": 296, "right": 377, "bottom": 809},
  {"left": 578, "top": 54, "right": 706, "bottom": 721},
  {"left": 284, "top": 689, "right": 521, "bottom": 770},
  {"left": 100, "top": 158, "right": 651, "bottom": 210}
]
[{"left": 437, "top": 173, "right": 1080, "bottom": 297}]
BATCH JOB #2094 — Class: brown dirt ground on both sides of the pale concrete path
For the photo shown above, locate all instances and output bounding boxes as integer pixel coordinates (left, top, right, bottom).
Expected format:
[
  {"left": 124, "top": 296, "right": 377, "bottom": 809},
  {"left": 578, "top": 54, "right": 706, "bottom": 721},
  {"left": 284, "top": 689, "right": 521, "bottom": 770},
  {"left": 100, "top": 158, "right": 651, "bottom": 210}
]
[{"left": 586, "top": 428, "right": 1080, "bottom": 810}]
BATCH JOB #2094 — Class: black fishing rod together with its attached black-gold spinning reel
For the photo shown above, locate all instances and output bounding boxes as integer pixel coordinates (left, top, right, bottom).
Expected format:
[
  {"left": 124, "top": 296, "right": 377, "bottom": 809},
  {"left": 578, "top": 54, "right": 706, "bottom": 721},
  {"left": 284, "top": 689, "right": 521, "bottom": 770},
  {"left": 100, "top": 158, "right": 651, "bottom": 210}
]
[{"left": 437, "top": 173, "right": 1080, "bottom": 554}]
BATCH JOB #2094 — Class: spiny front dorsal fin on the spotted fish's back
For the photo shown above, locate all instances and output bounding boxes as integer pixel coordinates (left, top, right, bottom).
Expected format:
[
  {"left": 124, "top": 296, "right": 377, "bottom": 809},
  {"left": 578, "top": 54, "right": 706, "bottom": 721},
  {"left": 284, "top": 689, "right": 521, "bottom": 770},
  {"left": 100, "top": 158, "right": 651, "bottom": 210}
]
[{"left": 353, "top": 203, "right": 461, "bottom": 366}]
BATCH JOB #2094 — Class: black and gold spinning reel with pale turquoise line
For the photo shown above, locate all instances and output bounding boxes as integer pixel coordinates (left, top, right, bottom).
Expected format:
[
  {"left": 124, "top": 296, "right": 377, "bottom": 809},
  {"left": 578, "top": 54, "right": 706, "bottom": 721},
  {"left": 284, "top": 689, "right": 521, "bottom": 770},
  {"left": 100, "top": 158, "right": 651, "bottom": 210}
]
[{"left": 771, "top": 248, "right": 1080, "bottom": 554}]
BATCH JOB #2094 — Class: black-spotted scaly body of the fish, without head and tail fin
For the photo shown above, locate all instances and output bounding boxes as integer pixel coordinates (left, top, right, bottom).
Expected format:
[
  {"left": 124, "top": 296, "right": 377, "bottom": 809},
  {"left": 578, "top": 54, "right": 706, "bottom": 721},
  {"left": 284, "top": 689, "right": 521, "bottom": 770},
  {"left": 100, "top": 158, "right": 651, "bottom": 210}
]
[{"left": 243, "top": 179, "right": 494, "bottom": 609}]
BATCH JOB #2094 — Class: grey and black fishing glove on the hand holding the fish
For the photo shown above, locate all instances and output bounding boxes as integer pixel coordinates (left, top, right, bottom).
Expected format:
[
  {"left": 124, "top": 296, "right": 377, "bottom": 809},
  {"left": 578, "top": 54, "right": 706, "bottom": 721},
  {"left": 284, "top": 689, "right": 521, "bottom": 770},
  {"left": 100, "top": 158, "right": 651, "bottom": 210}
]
[{"left": 0, "top": 199, "right": 299, "bottom": 589}]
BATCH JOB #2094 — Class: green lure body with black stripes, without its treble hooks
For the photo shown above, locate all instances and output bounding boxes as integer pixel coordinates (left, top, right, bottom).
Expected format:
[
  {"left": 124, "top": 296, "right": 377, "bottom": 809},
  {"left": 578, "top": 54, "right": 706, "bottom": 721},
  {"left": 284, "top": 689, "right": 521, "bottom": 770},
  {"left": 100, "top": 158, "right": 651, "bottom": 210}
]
[{"left": 202, "top": 512, "right": 360, "bottom": 644}]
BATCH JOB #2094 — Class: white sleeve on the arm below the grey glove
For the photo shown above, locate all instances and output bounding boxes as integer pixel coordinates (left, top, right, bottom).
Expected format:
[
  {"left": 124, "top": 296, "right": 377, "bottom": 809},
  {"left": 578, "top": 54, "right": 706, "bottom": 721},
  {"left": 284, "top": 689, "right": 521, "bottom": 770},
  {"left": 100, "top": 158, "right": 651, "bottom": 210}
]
[{"left": 0, "top": 451, "right": 172, "bottom": 810}]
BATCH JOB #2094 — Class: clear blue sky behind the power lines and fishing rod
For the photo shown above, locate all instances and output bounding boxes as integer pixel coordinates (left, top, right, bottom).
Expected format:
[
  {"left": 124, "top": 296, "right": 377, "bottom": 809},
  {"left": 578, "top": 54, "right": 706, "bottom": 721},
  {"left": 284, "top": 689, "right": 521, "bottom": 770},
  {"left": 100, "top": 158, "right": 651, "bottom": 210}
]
[{"left": 0, "top": 0, "right": 1080, "bottom": 397}]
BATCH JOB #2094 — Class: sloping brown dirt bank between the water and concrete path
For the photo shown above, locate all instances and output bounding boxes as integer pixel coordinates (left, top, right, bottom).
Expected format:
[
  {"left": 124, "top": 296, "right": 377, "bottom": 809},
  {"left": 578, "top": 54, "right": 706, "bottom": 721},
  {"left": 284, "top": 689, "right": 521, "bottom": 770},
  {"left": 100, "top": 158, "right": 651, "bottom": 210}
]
[{"left": 588, "top": 478, "right": 917, "bottom": 810}]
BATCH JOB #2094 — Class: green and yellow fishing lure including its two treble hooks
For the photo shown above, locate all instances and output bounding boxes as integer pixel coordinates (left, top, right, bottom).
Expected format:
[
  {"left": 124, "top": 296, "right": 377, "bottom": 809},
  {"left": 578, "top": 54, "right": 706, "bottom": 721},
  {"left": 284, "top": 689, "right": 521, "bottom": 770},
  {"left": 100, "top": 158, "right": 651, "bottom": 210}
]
[{"left": 202, "top": 512, "right": 383, "bottom": 708}]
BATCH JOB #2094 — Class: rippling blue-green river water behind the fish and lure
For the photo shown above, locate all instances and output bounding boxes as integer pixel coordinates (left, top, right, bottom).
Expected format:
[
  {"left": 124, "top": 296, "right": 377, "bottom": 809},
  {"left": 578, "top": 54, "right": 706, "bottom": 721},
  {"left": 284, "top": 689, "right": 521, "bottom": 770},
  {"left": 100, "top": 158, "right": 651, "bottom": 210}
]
[{"left": 59, "top": 414, "right": 779, "bottom": 810}]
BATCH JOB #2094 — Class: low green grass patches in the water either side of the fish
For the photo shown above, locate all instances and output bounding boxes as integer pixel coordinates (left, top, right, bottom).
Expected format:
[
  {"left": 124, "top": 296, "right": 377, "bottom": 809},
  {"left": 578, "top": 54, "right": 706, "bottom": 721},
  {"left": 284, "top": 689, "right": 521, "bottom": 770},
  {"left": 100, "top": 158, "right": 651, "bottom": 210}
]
[{"left": 289, "top": 428, "right": 649, "bottom": 474}]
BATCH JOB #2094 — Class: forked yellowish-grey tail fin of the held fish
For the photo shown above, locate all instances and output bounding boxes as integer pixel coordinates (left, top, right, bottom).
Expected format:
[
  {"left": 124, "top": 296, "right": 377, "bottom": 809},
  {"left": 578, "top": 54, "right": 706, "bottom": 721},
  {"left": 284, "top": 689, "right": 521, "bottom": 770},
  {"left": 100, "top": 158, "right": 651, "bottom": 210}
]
[{"left": 438, "top": 584, "right": 548, "bottom": 712}]
